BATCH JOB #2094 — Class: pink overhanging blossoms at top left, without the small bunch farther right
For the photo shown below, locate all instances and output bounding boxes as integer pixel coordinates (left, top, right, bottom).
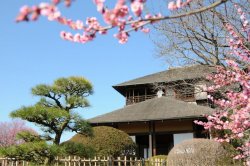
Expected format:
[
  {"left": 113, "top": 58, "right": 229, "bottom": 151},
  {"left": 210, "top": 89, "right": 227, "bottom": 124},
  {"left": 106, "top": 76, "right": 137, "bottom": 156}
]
[{"left": 16, "top": 0, "right": 152, "bottom": 43}]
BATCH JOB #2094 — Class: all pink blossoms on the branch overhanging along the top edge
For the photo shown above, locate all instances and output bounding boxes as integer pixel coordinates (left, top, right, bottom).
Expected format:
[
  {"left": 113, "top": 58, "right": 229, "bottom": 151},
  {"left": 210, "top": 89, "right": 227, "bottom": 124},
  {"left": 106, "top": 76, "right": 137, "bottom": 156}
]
[{"left": 16, "top": 0, "right": 219, "bottom": 44}]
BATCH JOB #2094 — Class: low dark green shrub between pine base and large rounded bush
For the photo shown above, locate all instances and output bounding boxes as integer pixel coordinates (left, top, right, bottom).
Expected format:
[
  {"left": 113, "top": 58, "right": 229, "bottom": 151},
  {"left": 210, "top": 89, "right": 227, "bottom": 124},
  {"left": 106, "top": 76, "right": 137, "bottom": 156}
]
[{"left": 60, "top": 142, "right": 95, "bottom": 158}]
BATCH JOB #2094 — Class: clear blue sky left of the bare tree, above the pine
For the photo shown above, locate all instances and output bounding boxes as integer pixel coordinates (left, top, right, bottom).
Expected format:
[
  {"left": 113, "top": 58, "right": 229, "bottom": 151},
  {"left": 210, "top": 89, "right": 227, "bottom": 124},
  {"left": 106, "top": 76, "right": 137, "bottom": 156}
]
[{"left": 0, "top": 0, "right": 167, "bottom": 140}]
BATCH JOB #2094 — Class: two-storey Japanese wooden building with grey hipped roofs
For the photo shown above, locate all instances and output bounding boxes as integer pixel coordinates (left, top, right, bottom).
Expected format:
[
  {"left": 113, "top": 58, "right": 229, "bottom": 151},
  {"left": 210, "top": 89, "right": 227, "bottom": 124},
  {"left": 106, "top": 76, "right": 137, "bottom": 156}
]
[{"left": 89, "top": 65, "right": 214, "bottom": 158}]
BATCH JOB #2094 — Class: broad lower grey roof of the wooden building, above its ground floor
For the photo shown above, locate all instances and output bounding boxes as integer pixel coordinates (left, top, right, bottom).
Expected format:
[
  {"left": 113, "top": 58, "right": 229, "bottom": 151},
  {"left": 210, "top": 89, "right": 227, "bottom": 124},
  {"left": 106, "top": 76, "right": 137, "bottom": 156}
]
[{"left": 89, "top": 97, "right": 213, "bottom": 124}]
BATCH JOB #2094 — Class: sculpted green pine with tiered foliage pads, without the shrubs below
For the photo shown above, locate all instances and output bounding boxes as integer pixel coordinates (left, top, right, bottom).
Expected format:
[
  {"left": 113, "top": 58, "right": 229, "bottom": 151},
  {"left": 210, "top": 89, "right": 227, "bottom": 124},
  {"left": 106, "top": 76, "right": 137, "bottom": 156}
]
[{"left": 10, "top": 77, "right": 93, "bottom": 145}]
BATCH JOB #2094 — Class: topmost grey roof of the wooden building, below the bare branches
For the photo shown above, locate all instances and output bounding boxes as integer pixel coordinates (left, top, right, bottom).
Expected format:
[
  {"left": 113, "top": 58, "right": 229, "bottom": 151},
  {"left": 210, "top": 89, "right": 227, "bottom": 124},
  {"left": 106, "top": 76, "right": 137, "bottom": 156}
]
[{"left": 113, "top": 65, "right": 215, "bottom": 89}]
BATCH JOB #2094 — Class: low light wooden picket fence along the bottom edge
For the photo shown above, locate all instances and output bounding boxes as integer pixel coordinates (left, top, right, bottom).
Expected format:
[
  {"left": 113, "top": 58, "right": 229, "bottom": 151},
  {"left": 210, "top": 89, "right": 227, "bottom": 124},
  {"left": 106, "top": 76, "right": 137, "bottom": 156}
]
[{"left": 0, "top": 156, "right": 166, "bottom": 166}]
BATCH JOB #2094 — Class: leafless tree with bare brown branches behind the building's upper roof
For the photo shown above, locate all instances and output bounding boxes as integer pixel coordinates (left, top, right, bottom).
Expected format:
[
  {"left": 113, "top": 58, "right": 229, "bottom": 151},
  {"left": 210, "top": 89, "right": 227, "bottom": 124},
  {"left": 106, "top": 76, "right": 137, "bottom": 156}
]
[{"left": 153, "top": 0, "right": 250, "bottom": 66}]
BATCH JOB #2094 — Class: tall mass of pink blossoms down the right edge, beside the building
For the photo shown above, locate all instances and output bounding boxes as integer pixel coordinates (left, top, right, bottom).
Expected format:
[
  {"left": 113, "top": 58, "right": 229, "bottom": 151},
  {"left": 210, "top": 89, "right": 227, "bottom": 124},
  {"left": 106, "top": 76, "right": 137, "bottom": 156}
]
[{"left": 195, "top": 5, "right": 250, "bottom": 165}]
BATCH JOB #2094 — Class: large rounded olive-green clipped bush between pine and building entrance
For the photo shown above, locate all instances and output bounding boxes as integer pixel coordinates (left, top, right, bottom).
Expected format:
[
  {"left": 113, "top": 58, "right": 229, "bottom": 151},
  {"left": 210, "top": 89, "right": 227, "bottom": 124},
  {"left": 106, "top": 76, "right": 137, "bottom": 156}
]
[{"left": 69, "top": 126, "right": 136, "bottom": 157}]
